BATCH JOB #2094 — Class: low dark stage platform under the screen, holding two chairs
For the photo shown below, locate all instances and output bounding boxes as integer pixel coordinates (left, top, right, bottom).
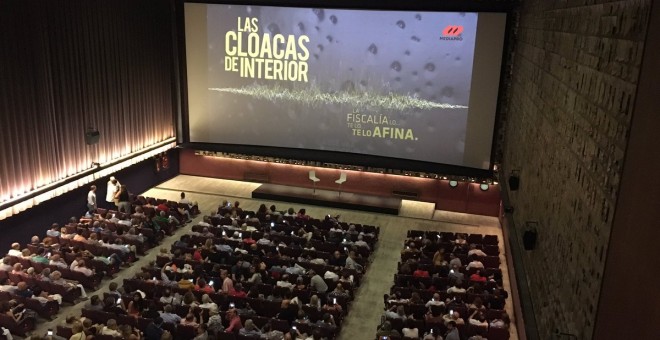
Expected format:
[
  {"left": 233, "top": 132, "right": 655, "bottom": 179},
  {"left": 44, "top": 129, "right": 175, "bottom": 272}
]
[{"left": 252, "top": 184, "right": 401, "bottom": 215}]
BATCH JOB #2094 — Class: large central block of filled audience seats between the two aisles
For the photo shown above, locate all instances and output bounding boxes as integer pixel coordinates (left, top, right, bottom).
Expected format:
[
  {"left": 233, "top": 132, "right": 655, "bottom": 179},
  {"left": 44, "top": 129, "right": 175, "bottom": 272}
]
[{"left": 58, "top": 205, "right": 380, "bottom": 340}]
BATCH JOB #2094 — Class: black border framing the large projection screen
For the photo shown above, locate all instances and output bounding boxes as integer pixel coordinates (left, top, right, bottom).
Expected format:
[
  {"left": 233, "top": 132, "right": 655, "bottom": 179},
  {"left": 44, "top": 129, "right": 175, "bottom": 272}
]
[{"left": 173, "top": 0, "right": 516, "bottom": 177}]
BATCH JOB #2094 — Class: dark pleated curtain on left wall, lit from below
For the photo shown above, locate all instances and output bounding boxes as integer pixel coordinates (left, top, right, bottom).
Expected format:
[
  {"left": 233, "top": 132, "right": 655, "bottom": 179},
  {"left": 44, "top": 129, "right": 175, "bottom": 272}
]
[{"left": 0, "top": 0, "right": 176, "bottom": 204}]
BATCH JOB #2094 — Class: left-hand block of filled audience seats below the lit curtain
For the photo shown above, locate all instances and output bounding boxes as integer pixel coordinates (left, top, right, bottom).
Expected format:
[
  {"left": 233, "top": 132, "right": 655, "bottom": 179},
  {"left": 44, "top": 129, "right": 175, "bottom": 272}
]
[{"left": 0, "top": 196, "right": 196, "bottom": 336}]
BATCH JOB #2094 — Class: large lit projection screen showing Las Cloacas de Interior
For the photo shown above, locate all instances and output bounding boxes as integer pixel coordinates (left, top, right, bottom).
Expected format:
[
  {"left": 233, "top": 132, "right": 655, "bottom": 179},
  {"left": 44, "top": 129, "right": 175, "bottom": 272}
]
[{"left": 184, "top": 3, "right": 506, "bottom": 169}]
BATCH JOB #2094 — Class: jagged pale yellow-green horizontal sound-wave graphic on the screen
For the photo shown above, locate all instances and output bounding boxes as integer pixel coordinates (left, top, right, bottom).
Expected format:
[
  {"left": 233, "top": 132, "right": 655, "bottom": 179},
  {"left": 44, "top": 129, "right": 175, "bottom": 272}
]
[{"left": 209, "top": 84, "right": 467, "bottom": 111}]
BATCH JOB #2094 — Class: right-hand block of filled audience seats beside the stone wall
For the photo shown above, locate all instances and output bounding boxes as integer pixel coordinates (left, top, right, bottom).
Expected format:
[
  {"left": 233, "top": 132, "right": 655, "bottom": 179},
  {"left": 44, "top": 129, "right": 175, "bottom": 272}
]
[{"left": 377, "top": 230, "right": 510, "bottom": 340}]
